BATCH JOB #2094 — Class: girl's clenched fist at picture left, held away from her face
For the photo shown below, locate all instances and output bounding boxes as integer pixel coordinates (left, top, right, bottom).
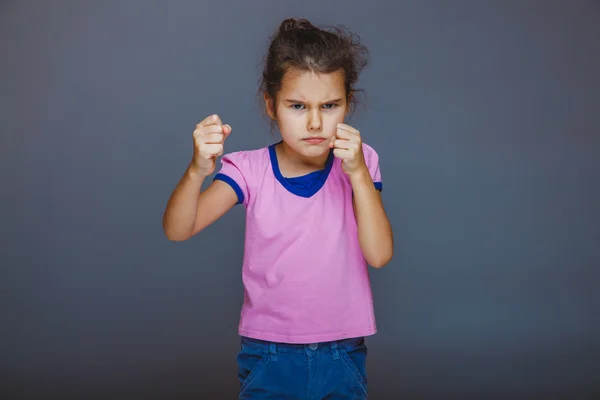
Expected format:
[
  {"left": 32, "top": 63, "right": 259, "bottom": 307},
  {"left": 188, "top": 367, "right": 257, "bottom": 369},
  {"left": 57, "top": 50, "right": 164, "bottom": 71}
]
[{"left": 192, "top": 115, "right": 231, "bottom": 176}]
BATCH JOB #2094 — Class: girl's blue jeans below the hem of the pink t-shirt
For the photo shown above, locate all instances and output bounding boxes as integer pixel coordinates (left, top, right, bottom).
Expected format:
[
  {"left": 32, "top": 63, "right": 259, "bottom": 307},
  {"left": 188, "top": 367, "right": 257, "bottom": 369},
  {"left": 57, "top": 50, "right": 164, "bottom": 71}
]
[{"left": 237, "top": 337, "right": 368, "bottom": 400}]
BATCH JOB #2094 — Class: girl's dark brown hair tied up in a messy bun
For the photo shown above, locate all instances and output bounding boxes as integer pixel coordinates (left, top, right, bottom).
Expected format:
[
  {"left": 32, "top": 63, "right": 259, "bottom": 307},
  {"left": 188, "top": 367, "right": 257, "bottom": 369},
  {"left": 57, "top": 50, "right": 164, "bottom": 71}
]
[{"left": 259, "top": 18, "right": 368, "bottom": 120}]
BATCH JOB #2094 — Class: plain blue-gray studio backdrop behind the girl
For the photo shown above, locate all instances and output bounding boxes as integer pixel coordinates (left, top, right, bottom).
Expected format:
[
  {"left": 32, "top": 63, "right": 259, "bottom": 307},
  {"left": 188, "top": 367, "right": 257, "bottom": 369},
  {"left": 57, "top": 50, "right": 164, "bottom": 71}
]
[{"left": 0, "top": 0, "right": 600, "bottom": 399}]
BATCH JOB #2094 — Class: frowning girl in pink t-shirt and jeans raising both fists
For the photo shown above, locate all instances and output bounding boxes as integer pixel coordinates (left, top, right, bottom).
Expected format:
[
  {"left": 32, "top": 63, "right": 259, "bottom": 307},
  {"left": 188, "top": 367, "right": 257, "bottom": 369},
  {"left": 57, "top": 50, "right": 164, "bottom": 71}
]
[{"left": 163, "top": 19, "right": 393, "bottom": 399}]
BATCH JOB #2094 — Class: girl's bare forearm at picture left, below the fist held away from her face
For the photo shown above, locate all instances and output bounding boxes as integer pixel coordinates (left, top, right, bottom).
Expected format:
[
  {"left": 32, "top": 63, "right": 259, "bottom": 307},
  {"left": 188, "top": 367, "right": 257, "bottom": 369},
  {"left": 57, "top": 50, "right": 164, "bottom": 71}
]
[{"left": 163, "top": 164, "right": 206, "bottom": 240}]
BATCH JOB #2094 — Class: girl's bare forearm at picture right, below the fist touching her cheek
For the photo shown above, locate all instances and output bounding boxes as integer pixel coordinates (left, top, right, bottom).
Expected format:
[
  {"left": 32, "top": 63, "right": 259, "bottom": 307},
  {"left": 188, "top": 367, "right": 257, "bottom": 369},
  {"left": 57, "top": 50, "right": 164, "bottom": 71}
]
[{"left": 350, "top": 169, "right": 394, "bottom": 268}]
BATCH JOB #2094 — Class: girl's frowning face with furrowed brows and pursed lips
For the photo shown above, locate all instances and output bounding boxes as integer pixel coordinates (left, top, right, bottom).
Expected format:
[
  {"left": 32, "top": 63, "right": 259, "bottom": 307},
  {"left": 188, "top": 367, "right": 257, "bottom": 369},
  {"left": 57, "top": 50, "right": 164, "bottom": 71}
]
[{"left": 267, "top": 70, "right": 348, "bottom": 157}]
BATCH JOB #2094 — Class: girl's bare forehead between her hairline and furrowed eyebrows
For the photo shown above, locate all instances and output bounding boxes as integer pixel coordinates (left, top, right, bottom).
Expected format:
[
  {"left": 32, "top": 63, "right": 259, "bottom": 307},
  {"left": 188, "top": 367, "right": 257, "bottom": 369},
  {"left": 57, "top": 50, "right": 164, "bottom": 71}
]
[{"left": 280, "top": 69, "right": 346, "bottom": 102}]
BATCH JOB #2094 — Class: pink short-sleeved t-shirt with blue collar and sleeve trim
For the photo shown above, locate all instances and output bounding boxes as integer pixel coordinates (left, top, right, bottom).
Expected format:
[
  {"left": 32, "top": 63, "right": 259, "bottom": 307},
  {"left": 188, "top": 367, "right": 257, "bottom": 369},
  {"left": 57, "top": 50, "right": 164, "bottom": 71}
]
[{"left": 214, "top": 144, "right": 381, "bottom": 343}]
